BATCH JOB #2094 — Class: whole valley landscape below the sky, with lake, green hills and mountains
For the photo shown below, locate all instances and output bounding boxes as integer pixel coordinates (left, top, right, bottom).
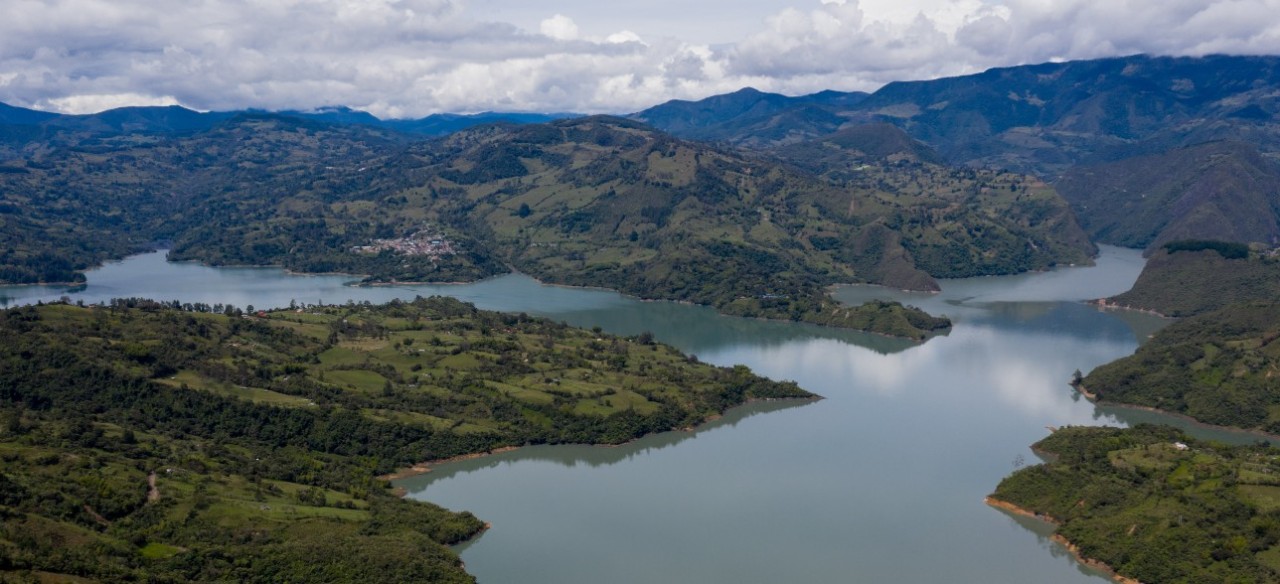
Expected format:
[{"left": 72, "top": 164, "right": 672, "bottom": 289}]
[{"left": 0, "top": 55, "right": 1280, "bottom": 584}]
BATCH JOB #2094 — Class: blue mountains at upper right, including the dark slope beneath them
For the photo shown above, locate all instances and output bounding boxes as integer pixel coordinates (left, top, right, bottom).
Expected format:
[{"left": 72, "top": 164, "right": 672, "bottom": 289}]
[{"left": 636, "top": 55, "right": 1280, "bottom": 253}]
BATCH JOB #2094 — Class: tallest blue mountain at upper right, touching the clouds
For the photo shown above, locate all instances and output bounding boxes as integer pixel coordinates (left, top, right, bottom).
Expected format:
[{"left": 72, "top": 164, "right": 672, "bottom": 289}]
[{"left": 858, "top": 55, "right": 1280, "bottom": 173}]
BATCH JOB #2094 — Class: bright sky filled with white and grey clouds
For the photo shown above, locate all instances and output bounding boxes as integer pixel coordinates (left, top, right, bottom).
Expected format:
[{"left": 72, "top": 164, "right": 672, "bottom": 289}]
[{"left": 0, "top": 0, "right": 1280, "bottom": 118}]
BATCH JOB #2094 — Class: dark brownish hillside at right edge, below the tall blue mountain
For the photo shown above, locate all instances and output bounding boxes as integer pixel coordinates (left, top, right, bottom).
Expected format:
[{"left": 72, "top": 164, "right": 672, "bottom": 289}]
[{"left": 1053, "top": 141, "right": 1280, "bottom": 252}]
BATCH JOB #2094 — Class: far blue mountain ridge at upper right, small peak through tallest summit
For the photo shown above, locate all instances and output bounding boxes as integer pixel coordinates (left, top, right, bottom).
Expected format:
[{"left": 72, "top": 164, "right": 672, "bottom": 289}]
[{"left": 631, "top": 55, "right": 1280, "bottom": 178}]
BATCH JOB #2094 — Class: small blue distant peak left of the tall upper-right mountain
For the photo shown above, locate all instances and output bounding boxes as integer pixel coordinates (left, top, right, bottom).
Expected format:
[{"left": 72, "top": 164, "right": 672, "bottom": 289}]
[{"left": 630, "top": 87, "right": 867, "bottom": 146}]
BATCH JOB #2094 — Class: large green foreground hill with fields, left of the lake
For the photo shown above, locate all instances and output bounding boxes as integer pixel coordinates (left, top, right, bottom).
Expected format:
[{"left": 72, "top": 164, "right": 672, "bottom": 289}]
[{"left": 0, "top": 298, "right": 814, "bottom": 583}]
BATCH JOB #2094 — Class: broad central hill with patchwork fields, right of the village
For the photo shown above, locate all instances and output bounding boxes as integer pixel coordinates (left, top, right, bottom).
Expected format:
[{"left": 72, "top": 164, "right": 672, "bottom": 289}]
[{"left": 368, "top": 118, "right": 1092, "bottom": 332}]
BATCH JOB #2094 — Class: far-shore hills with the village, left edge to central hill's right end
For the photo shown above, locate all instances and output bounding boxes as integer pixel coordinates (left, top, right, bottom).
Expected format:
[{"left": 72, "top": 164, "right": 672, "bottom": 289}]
[{"left": 0, "top": 115, "right": 1093, "bottom": 338}]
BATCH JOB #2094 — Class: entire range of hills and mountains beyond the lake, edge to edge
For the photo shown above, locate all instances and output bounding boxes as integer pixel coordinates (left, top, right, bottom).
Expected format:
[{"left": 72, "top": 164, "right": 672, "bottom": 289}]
[{"left": 0, "top": 51, "right": 1280, "bottom": 326}]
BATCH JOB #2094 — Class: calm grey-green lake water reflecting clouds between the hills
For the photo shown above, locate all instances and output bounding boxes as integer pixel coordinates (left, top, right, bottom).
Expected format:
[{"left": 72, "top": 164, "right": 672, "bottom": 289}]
[{"left": 0, "top": 248, "right": 1252, "bottom": 584}]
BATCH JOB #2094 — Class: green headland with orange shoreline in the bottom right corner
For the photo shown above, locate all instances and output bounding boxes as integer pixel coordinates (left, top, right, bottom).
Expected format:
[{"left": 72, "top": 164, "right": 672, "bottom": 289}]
[{"left": 988, "top": 425, "right": 1280, "bottom": 584}]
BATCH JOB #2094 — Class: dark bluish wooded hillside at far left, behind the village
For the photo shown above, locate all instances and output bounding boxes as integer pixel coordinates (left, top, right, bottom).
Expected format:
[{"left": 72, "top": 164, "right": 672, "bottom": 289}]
[{"left": 0, "top": 115, "right": 481, "bottom": 283}]
